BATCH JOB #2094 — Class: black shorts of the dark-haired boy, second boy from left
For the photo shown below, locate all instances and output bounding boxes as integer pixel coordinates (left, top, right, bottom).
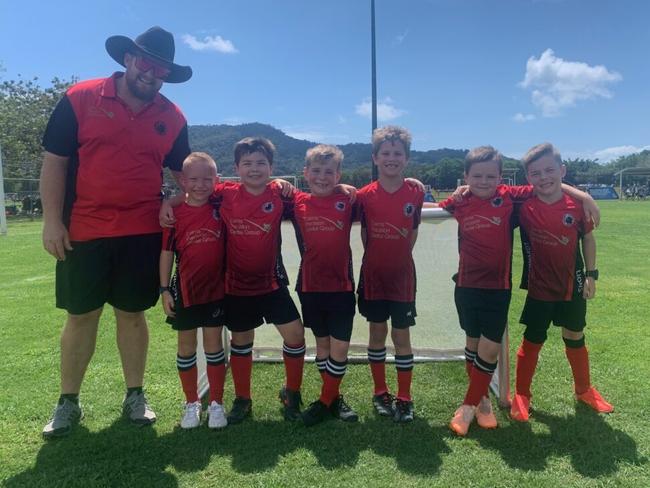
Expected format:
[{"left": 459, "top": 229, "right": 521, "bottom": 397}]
[{"left": 226, "top": 286, "right": 300, "bottom": 332}]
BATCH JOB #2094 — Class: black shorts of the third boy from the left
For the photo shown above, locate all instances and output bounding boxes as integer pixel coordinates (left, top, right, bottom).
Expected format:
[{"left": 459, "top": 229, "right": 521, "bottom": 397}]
[{"left": 298, "top": 291, "right": 356, "bottom": 342}]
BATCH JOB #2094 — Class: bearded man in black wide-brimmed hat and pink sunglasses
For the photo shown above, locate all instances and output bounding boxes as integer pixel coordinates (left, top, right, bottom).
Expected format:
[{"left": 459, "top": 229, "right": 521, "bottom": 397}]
[{"left": 41, "top": 27, "right": 192, "bottom": 437}]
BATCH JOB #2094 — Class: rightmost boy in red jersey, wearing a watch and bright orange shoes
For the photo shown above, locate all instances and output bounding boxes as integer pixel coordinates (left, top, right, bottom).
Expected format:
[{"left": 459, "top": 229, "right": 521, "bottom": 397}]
[{"left": 510, "top": 143, "right": 614, "bottom": 422}]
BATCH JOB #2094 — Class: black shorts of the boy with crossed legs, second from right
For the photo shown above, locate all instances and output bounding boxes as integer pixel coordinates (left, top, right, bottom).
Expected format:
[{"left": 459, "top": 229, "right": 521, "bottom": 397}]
[{"left": 454, "top": 286, "right": 512, "bottom": 343}]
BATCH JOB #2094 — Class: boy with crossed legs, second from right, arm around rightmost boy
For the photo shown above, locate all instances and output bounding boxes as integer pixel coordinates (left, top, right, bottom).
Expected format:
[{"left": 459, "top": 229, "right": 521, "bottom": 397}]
[{"left": 436, "top": 146, "right": 598, "bottom": 436}]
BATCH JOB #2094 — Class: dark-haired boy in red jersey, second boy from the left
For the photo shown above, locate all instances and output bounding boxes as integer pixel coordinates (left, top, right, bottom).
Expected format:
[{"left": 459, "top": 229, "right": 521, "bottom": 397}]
[{"left": 161, "top": 137, "right": 305, "bottom": 424}]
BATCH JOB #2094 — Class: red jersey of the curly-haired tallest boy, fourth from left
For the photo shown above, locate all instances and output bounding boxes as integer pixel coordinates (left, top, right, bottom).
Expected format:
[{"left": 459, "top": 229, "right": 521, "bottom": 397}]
[{"left": 357, "top": 181, "right": 424, "bottom": 302}]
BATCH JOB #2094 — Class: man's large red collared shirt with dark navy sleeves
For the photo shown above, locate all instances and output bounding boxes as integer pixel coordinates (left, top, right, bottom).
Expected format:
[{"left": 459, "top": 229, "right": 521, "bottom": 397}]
[{"left": 43, "top": 73, "right": 190, "bottom": 241}]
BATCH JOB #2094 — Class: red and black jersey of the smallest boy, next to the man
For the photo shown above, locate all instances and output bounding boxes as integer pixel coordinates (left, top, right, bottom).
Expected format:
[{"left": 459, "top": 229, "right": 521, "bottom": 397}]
[{"left": 163, "top": 203, "right": 225, "bottom": 307}]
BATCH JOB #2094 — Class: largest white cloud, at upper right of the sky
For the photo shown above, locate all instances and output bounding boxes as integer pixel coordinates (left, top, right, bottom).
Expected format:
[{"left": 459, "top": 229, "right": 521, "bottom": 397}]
[{"left": 520, "top": 49, "right": 623, "bottom": 117}]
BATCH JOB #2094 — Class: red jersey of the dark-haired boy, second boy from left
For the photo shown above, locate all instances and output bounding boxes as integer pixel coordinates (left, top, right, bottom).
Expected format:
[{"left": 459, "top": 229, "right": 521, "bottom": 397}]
[{"left": 214, "top": 183, "right": 291, "bottom": 296}]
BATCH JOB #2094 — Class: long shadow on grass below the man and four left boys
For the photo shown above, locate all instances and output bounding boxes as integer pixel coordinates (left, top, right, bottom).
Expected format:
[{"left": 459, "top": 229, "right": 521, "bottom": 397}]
[{"left": 6, "top": 412, "right": 449, "bottom": 488}]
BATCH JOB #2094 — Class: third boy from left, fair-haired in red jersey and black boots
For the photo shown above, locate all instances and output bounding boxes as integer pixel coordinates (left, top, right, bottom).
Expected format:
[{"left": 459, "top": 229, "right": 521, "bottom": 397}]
[{"left": 292, "top": 144, "right": 359, "bottom": 426}]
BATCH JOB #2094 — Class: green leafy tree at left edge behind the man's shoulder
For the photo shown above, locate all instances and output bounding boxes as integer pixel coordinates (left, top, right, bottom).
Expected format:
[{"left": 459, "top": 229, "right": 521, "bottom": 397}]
[{"left": 0, "top": 77, "right": 76, "bottom": 182}]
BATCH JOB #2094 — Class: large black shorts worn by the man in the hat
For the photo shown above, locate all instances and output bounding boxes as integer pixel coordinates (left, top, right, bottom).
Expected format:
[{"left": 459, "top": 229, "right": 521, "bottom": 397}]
[{"left": 56, "top": 233, "right": 162, "bottom": 315}]
